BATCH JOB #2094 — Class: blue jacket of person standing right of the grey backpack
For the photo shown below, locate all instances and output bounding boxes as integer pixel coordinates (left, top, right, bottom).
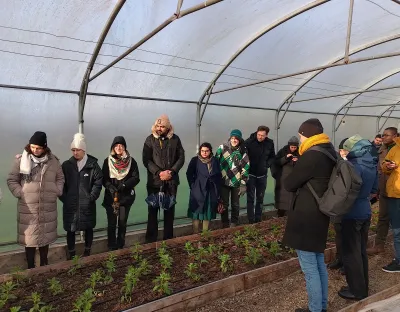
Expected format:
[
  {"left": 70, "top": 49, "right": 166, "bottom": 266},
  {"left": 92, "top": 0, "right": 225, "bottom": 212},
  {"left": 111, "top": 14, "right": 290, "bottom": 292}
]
[{"left": 342, "top": 140, "right": 378, "bottom": 220}]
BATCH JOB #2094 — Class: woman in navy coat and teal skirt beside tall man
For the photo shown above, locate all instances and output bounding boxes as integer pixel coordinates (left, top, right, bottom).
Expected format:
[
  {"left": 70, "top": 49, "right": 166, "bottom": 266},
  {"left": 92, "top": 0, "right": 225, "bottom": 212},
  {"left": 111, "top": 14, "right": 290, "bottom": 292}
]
[{"left": 186, "top": 143, "right": 222, "bottom": 233}]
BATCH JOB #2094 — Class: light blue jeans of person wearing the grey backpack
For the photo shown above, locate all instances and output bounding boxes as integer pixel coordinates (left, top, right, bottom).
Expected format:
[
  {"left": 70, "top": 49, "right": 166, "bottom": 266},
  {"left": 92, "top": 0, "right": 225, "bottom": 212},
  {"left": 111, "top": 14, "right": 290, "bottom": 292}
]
[{"left": 296, "top": 250, "right": 328, "bottom": 312}]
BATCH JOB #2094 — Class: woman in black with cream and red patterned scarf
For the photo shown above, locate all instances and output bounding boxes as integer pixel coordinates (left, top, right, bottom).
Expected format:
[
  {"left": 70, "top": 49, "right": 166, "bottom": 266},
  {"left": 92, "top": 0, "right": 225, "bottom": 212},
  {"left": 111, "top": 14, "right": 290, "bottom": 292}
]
[{"left": 103, "top": 136, "right": 140, "bottom": 250}]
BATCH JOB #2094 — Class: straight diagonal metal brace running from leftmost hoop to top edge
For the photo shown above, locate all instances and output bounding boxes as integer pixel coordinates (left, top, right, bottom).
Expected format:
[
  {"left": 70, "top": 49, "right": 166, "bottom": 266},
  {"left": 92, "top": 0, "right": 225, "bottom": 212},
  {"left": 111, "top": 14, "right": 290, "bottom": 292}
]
[{"left": 89, "top": 0, "right": 222, "bottom": 81}]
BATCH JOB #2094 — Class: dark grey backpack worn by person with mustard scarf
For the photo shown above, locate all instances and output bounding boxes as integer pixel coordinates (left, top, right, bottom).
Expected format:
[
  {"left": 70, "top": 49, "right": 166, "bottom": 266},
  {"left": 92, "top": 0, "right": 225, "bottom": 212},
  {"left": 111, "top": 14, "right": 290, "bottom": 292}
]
[{"left": 307, "top": 146, "right": 362, "bottom": 217}]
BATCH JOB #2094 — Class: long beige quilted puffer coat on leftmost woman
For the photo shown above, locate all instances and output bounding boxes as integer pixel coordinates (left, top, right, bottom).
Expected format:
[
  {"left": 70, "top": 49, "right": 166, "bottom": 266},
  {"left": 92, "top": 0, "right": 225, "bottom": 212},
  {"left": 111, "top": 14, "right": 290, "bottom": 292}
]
[{"left": 7, "top": 153, "right": 64, "bottom": 247}]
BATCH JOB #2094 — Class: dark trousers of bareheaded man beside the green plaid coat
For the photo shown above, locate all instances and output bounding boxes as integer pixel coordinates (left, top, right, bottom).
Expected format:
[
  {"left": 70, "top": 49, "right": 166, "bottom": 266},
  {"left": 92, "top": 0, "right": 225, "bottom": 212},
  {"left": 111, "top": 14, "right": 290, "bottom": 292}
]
[{"left": 247, "top": 176, "right": 267, "bottom": 223}]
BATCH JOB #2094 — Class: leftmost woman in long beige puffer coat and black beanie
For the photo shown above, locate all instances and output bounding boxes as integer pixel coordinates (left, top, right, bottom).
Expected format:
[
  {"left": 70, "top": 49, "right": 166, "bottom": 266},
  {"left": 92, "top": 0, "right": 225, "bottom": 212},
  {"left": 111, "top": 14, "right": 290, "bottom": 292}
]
[{"left": 7, "top": 131, "right": 64, "bottom": 269}]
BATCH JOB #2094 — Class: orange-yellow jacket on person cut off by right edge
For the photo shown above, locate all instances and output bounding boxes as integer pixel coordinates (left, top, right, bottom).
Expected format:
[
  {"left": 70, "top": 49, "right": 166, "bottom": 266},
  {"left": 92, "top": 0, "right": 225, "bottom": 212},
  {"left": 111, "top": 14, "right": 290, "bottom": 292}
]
[{"left": 380, "top": 138, "right": 400, "bottom": 198}]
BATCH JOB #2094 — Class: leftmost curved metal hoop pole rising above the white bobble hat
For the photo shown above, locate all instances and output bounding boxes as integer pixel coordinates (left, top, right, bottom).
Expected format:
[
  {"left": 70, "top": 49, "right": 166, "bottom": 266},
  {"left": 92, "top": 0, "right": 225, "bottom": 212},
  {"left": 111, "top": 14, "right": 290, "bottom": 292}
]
[{"left": 78, "top": 0, "right": 126, "bottom": 133}]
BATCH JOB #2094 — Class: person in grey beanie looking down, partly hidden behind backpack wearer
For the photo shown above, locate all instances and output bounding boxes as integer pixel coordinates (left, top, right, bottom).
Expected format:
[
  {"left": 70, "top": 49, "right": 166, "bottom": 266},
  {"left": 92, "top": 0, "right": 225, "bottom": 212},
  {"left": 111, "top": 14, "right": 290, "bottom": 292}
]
[{"left": 274, "top": 136, "right": 299, "bottom": 217}]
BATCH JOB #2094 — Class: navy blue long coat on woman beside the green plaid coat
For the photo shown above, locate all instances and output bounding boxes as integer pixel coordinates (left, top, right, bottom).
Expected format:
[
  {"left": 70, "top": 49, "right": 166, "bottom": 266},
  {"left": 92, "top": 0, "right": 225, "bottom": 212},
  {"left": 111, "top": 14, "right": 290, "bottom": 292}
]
[{"left": 186, "top": 156, "right": 222, "bottom": 213}]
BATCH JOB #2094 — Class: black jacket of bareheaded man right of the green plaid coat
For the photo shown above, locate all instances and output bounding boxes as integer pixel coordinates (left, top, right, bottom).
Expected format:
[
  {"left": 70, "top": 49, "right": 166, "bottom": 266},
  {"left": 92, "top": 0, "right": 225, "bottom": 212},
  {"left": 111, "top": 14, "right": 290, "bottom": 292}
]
[{"left": 245, "top": 132, "right": 275, "bottom": 177}]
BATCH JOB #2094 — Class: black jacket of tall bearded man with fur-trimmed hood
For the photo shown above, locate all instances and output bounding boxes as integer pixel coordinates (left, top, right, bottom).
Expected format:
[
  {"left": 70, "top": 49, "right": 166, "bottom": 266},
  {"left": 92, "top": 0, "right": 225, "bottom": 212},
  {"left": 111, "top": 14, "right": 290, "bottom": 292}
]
[{"left": 143, "top": 134, "right": 185, "bottom": 188}]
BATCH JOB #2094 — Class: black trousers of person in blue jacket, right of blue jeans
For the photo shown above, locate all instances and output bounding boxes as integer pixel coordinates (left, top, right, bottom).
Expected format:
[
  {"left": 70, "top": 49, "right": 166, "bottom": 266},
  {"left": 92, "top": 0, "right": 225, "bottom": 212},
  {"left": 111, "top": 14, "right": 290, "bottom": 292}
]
[{"left": 342, "top": 219, "right": 371, "bottom": 298}]
